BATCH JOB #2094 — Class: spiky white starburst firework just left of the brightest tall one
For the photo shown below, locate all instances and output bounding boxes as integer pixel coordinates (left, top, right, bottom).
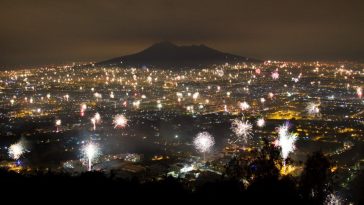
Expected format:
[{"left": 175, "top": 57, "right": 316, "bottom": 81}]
[{"left": 231, "top": 117, "right": 253, "bottom": 143}]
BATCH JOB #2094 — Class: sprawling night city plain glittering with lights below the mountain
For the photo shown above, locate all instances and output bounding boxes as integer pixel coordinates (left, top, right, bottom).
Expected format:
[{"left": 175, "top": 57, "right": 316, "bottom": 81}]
[{"left": 1, "top": 61, "right": 364, "bottom": 200}]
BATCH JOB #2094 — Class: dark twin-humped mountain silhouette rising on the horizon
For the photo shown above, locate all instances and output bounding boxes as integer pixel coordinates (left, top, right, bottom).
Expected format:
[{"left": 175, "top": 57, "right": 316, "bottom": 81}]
[{"left": 96, "top": 41, "right": 261, "bottom": 68}]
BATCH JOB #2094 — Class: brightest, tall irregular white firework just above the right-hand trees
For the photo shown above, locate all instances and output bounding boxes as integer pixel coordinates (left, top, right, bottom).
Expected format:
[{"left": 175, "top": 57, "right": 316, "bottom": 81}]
[{"left": 276, "top": 124, "right": 297, "bottom": 163}]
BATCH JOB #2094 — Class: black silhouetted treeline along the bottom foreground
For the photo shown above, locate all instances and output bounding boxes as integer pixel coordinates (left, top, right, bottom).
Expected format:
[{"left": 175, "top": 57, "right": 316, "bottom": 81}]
[{"left": 0, "top": 139, "right": 364, "bottom": 204}]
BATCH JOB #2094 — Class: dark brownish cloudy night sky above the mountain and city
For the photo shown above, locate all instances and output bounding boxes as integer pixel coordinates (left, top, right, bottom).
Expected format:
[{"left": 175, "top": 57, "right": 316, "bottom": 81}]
[{"left": 0, "top": 0, "right": 364, "bottom": 67}]
